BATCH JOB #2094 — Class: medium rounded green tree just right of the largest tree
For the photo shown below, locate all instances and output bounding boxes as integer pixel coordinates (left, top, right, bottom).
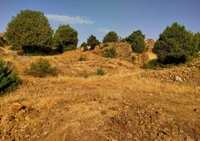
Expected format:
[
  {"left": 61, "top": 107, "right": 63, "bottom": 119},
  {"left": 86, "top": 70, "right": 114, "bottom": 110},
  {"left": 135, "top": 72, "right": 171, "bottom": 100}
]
[{"left": 54, "top": 25, "right": 78, "bottom": 53}]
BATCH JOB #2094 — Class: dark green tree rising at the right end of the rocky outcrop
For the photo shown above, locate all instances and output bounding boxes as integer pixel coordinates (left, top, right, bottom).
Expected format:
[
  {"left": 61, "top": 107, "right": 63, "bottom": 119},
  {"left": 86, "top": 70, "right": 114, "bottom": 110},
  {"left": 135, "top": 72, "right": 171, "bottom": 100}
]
[{"left": 124, "top": 30, "right": 145, "bottom": 53}]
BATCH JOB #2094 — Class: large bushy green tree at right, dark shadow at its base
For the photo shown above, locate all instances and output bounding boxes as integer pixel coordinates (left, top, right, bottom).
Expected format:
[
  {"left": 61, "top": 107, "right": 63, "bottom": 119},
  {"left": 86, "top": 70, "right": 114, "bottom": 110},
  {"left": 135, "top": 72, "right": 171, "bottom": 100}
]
[{"left": 154, "top": 22, "right": 198, "bottom": 64}]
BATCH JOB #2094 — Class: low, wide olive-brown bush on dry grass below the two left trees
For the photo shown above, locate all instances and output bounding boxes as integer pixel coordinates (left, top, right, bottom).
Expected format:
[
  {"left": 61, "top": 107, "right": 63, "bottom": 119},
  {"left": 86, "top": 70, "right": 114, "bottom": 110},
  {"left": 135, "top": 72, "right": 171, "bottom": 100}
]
[{"left": 25, "top": 58, "right": 57, "bottom": 77}]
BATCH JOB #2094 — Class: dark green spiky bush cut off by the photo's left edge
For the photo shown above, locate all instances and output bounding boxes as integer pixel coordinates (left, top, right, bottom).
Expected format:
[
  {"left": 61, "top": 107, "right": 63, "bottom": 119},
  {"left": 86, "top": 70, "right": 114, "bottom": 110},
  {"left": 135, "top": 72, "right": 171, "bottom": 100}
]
[{"left": 0, "top": 58, "right": 19, "bottom": 96}]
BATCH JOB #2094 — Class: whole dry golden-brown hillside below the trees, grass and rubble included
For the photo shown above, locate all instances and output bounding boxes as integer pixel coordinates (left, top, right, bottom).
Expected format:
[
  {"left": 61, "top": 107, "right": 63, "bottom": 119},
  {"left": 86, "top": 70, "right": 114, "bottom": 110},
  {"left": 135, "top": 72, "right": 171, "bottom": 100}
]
[{"left": 0, "top": 41, "right": 200, "bottom": 141}]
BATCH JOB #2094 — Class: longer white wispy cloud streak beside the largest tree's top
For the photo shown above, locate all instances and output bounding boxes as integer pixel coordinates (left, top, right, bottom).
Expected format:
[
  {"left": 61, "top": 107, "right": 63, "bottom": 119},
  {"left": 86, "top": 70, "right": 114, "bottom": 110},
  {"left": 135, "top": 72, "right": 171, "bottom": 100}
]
[{"left": 45, "top": 15, "right": 94, "bottom": 24}]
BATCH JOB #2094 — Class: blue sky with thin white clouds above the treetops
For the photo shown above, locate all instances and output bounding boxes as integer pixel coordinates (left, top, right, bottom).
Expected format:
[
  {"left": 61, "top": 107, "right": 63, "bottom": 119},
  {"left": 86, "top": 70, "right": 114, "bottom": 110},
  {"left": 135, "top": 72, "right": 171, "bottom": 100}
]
[{"left": 0, "top": 0, "right": 200, "bottom": 45}]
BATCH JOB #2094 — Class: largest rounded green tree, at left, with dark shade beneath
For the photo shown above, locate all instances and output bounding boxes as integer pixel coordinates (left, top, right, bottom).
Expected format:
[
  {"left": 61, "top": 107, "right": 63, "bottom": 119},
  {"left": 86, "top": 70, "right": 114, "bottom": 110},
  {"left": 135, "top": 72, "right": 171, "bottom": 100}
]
[{"left": 5, "top": 10, "right": 53, "bottom": 52}]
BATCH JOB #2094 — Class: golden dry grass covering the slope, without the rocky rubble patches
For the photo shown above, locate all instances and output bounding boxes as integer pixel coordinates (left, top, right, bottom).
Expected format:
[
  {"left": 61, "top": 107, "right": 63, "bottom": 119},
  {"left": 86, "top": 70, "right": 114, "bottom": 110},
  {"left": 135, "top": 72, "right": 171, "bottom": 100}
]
[{"left": 0, "top": 46, "right": 200, "bottom": 140}]
